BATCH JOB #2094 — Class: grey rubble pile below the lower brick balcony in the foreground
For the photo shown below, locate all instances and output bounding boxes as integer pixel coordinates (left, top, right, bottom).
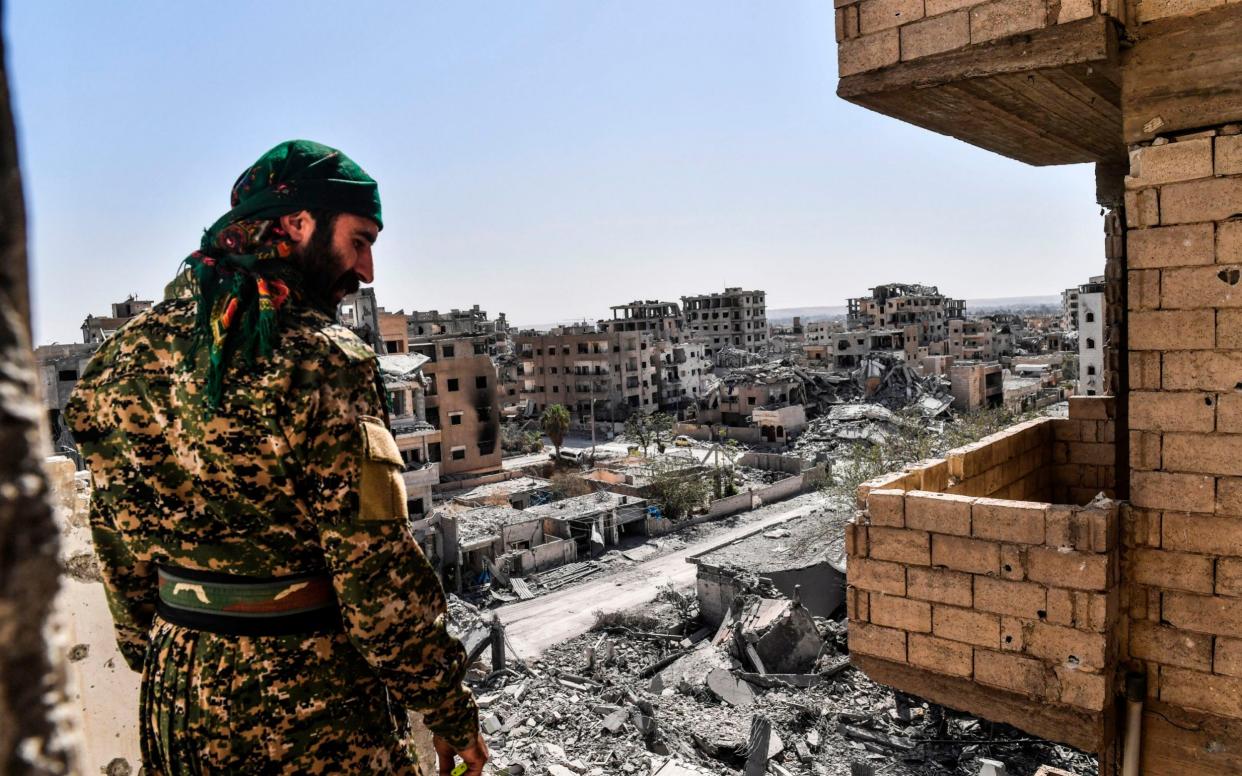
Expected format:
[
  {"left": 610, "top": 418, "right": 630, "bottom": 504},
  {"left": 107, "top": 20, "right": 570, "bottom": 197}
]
[{"left": 472, "top": 587, "right": 1097, "bottom": 776}]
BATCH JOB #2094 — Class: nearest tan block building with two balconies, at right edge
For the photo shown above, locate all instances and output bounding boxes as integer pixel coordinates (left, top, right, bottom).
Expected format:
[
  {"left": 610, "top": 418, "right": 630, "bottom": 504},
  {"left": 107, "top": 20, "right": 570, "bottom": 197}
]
[{"left": 836, "top": 0, "right": 1242, "bottom": 776}]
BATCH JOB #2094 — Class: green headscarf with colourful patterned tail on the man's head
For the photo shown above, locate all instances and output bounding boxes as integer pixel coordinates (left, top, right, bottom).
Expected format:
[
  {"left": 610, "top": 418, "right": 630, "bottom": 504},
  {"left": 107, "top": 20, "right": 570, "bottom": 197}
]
[{"left": 185, "top": 140, "right": 384, "bottom": 410}]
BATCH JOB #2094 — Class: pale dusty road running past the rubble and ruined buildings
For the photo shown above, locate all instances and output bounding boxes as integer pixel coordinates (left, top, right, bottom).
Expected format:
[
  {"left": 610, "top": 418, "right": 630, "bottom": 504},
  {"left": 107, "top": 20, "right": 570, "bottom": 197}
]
[{"left": 496, "top": 494, "right": 823, "bottom": 659}]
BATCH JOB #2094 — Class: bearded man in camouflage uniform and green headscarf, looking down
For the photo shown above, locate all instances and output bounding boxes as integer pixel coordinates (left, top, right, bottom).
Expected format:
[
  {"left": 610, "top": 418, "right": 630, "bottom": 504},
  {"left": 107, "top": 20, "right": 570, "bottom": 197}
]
[{"left": 66, "top": 140, "right": 487, "bottom": 775}]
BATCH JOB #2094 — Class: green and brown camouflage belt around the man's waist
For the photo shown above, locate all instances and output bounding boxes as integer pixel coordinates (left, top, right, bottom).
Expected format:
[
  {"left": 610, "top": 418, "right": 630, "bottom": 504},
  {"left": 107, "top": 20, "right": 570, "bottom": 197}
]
[{"left": 155, "top": 566, "right": 342, "bottom": 636}]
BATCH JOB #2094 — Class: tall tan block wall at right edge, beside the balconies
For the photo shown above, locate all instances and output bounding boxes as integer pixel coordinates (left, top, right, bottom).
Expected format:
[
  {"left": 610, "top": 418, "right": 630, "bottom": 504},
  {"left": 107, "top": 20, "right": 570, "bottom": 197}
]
[{"left": 1123, "top": 127, "right": 1242, "bottom": 720}]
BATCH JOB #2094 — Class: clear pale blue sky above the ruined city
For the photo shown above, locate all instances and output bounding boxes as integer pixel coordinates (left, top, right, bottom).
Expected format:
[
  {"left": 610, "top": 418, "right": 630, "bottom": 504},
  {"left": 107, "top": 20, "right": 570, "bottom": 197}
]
[{"left": 5, "top": 0, "right": 1104, "bottom": 344}]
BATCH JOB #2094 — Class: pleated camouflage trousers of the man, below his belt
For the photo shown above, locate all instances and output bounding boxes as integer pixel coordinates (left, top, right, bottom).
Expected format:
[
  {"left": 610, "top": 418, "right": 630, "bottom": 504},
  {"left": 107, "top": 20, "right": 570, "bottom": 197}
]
[{"left": 139, "top": 617, "right": 424, "bottom": 776}]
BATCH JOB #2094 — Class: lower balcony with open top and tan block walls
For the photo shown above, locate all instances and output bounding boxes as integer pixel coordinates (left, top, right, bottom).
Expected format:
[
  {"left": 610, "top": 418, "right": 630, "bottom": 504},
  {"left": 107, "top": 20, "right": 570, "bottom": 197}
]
[{"left": 846, "top": 397, "right": 1120, "bottom": 752}]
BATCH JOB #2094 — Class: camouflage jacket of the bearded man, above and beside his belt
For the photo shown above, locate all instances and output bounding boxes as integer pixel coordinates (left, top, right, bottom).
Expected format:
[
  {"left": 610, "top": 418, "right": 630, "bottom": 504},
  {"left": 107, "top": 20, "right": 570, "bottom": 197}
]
[{"left": 66, "top": 299, "right": 478, "bottom": 746}]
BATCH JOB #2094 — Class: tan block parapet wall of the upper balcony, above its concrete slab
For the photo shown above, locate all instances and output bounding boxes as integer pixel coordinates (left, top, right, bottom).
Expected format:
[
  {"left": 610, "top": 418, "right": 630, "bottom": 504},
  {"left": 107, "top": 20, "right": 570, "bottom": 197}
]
[{"left": 836, "top": 0, "right": 1102, "bottom": 76}]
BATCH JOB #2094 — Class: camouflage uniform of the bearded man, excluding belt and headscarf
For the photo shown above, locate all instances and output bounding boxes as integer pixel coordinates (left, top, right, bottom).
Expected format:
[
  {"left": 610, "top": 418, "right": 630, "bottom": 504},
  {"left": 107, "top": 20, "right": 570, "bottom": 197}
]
[{"left": 66, "top": 299, "right": 478, "bottom": 774}]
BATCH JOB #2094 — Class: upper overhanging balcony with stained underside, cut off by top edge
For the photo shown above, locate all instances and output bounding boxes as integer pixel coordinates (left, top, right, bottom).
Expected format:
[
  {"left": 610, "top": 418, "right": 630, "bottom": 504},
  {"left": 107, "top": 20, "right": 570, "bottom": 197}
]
[{"left": 836, "top": 6, "right": 1127, "bottom": 165}]
